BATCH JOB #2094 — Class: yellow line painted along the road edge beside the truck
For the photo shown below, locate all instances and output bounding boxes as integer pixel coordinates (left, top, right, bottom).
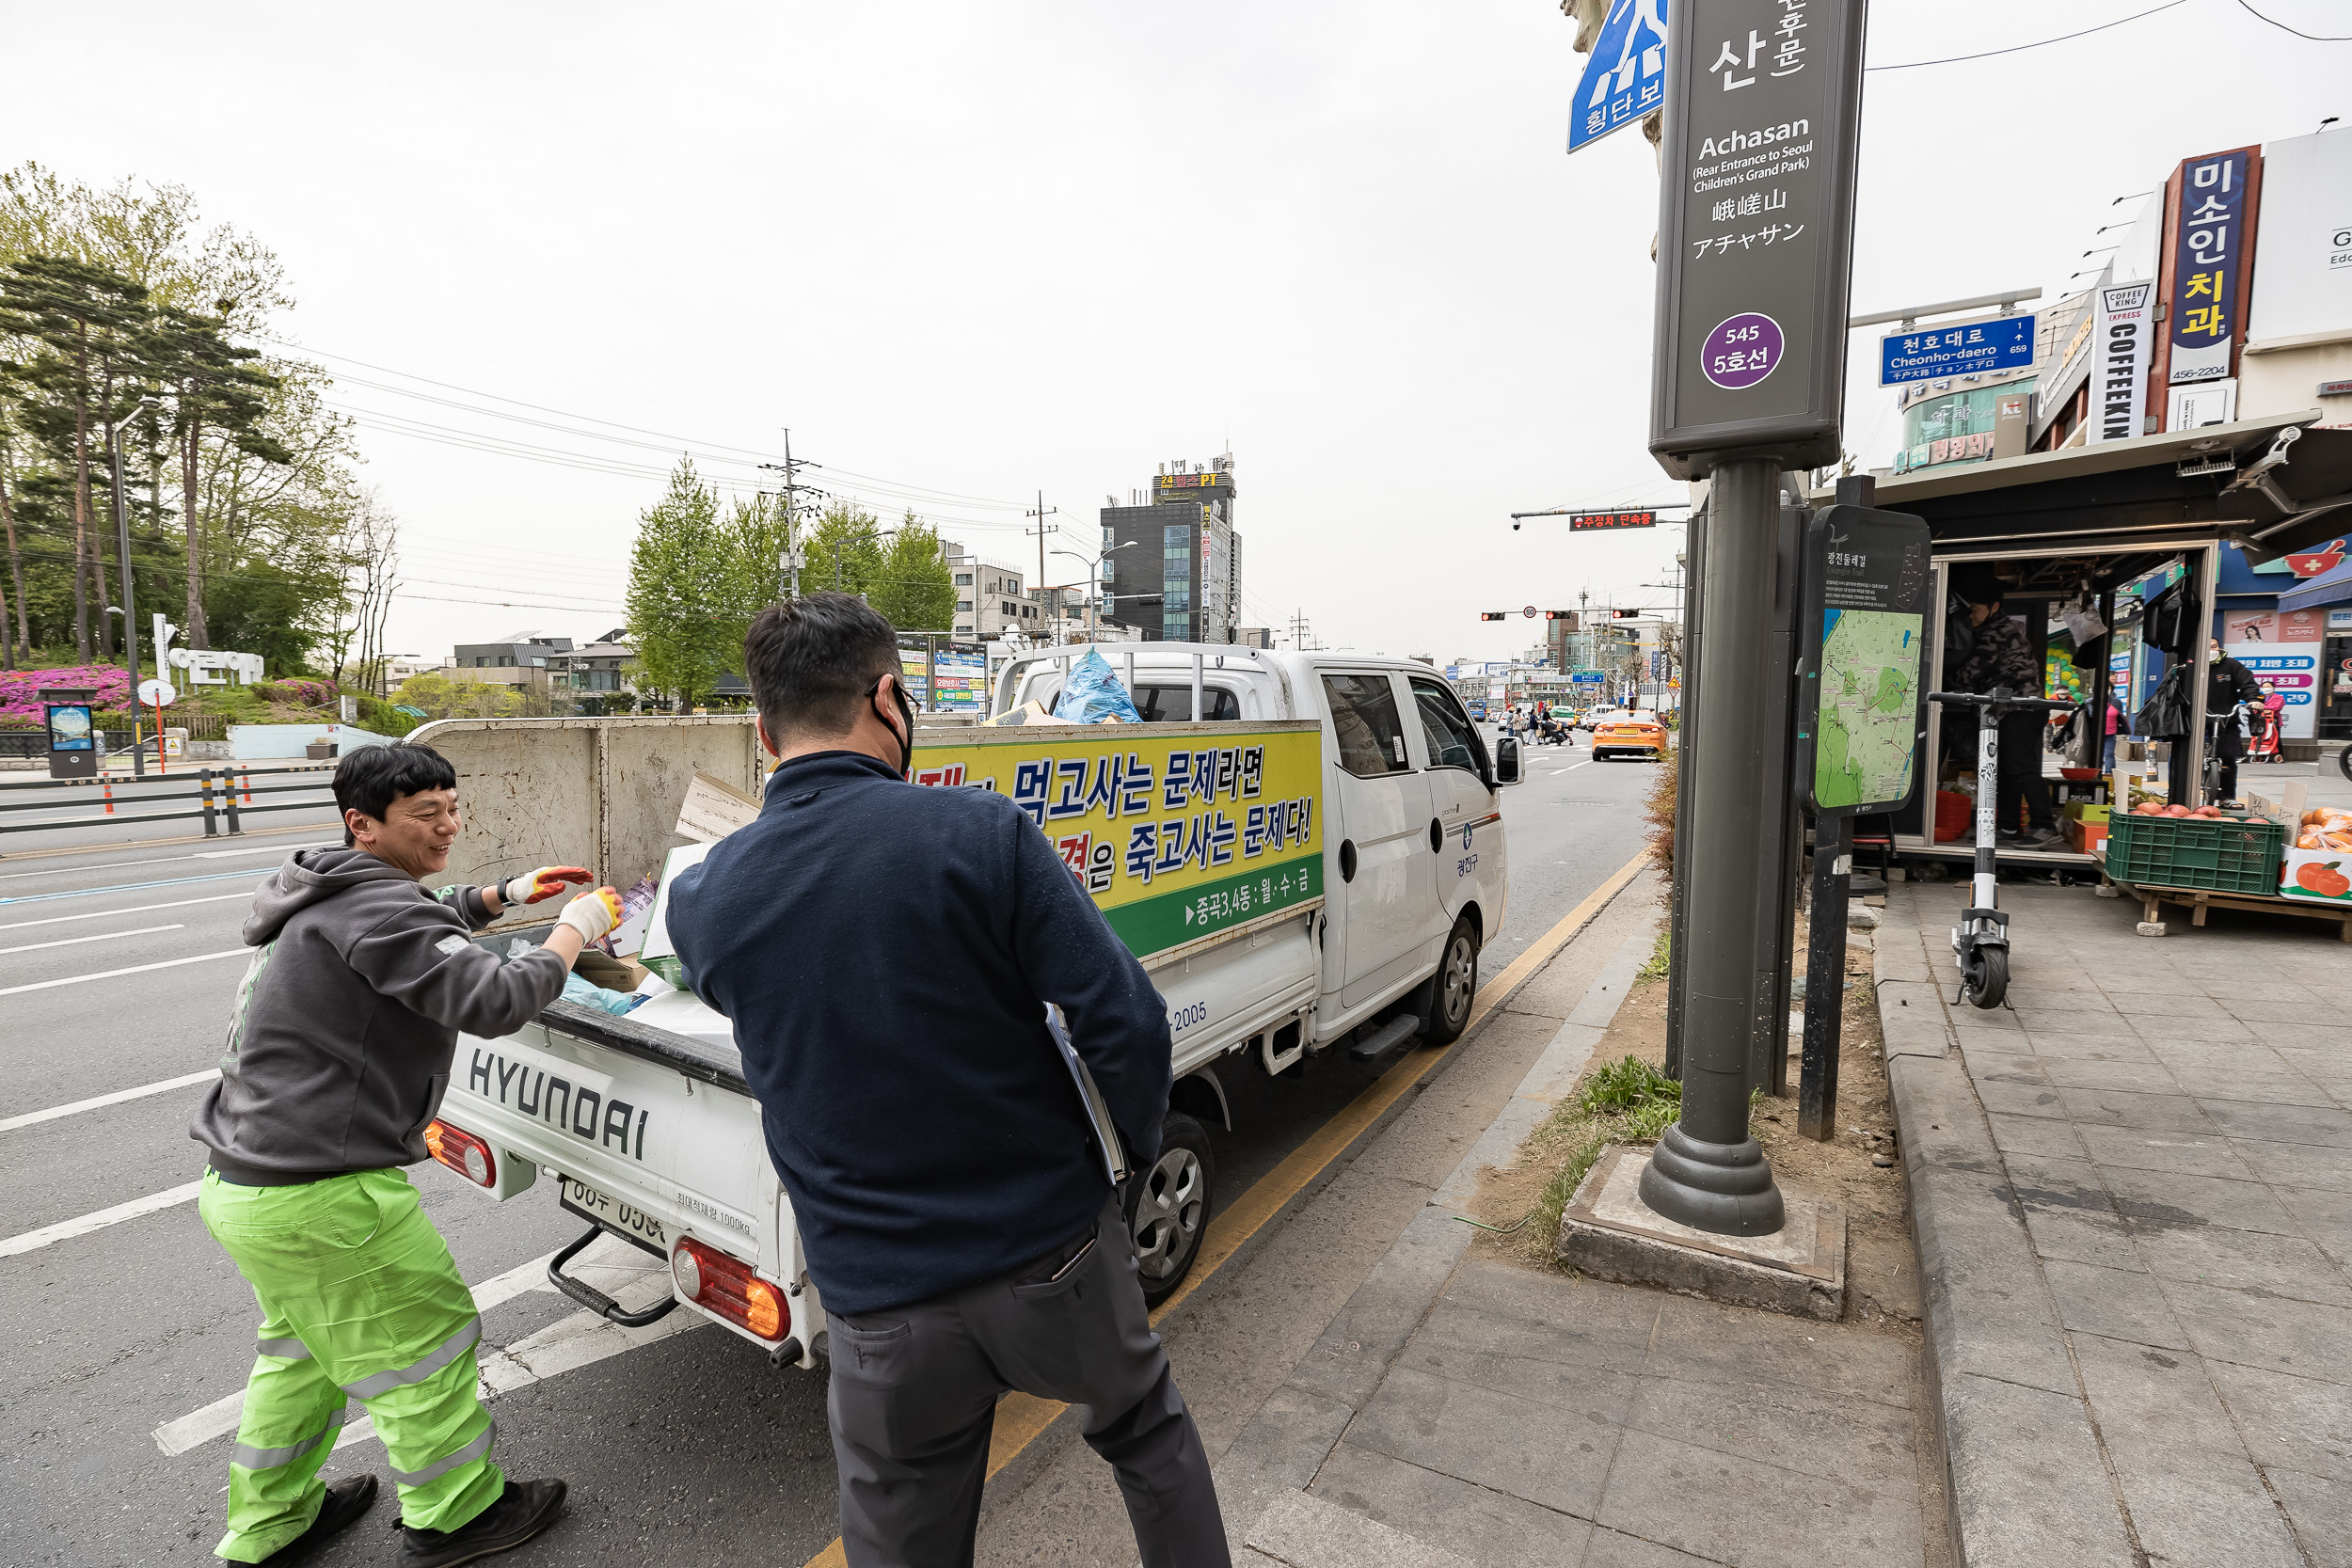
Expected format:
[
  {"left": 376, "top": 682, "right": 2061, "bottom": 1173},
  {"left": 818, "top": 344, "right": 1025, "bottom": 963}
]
[{"left": 807, "top": 848, "right": 1649, "bottom": 1568}]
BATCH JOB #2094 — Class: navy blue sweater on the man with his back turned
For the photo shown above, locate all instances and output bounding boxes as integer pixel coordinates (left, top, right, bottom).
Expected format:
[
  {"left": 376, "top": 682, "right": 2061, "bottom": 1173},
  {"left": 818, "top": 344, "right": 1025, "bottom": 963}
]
[{"left": 668, "top": 752, "right": 1171, "bottom": 1312}]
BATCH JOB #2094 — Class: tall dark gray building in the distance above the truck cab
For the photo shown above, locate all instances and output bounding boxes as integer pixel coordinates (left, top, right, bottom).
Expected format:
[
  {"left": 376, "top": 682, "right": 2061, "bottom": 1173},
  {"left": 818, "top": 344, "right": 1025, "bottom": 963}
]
[{"left": 1104, "top": 451, "right": 1242, "bottom": 641}]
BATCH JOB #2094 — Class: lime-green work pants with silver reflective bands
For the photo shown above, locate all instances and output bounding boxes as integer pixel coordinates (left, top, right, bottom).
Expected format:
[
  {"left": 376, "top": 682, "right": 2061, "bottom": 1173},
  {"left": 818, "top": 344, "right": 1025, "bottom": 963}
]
[{"left": 198, "top": 1171, "right": 506, "bottom": 1563}]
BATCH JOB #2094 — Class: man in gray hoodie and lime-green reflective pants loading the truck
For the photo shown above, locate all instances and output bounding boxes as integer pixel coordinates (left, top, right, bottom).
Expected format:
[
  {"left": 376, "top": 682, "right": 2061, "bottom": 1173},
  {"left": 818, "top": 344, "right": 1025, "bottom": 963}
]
[{"left": 188, "top": 745, "right": 621, "bottom": 1568}]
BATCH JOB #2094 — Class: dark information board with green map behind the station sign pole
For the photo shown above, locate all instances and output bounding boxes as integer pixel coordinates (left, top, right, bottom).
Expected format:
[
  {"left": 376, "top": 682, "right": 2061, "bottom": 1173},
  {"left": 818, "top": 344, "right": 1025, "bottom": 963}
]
[{"left": 1797, "top": 505, "right": 1933, "bottom": 816}]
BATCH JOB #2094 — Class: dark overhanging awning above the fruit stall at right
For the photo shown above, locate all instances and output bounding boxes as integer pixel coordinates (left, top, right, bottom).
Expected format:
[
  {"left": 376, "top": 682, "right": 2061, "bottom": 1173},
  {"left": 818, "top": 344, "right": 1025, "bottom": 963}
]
[{"left": 1814, "top": 409, "right": 2352, "bottom": 562}]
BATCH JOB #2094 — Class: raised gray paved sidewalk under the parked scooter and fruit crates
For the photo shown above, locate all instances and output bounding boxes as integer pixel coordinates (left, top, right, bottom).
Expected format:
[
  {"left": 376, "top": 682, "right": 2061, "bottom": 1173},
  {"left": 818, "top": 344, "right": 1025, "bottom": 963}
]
[{"left": 1877, "top": 884, "right": 2352, "bottom": 1568}]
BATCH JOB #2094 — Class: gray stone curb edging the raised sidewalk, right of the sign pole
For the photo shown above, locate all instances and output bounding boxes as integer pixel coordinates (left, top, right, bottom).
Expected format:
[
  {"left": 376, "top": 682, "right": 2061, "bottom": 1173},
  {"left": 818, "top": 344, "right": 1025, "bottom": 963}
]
[{"left": 1872, "top": 900, "right": 2145, "bottom": 1568}]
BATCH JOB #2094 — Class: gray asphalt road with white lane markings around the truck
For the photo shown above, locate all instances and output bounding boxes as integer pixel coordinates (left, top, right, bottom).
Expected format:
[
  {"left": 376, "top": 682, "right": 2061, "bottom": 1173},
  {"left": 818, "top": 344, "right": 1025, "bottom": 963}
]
[{"left": 0, "top": 743, "right": 1654, "bottom": 1568}]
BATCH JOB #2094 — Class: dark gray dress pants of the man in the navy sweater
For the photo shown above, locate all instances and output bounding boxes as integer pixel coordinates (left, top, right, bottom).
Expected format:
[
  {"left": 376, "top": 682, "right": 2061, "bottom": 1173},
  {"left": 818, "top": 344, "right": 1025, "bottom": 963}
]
[{"left": 826, "top": 1199, "right": 1232, "bottom": 1568}]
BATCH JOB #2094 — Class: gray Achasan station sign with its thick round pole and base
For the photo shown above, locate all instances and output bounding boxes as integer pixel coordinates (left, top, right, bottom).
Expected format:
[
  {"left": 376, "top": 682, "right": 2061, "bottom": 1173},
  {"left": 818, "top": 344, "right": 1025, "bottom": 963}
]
[{"left": 1640, "top": 0, "right": 1866, "bottom": 1237}]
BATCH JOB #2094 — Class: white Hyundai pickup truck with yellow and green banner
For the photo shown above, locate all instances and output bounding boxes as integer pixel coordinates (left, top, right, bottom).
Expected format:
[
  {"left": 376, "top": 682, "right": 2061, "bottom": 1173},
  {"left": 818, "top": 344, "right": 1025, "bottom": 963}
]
[{"left": 412, "top": 641, "right": 1522, "bottom": 1366}]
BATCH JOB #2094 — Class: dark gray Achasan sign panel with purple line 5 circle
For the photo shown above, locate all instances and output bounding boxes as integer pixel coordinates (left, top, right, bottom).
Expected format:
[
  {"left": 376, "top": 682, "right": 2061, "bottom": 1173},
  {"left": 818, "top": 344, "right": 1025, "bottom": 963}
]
[{"left": 1649, "top": 0, "right": 1863, "bottom": 480}]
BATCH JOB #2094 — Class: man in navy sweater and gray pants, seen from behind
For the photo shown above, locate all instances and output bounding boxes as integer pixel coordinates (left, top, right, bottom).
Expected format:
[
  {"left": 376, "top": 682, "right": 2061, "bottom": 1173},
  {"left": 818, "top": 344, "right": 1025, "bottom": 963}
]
[{"left": 668, "top": 593, "right": 1231, "bottom": 1568}]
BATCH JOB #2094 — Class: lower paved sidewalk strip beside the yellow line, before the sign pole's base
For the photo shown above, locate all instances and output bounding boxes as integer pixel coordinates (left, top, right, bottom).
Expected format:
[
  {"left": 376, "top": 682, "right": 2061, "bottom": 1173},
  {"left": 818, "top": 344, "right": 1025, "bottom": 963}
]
[{"left": 1216, "top": 917, "right": 1941, "bottom": 1568}]
